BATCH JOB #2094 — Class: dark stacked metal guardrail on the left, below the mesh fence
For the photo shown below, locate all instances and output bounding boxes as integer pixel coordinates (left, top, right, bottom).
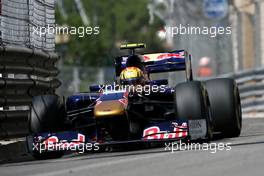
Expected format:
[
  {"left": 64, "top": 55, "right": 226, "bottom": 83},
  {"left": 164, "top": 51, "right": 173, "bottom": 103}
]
[{"left": 0, "top": 47, "right": 60, "bottom": 139}]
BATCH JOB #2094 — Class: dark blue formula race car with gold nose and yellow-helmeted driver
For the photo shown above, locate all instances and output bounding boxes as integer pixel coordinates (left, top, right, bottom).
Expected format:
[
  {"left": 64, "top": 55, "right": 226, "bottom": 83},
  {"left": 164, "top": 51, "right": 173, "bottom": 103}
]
[{"left": 27, "top": 44, "right": 242, "bottom": 159}]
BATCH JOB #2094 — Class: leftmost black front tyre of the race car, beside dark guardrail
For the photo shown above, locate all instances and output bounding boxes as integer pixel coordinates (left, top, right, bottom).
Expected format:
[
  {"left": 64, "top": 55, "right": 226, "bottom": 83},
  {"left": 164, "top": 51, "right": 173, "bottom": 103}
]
[{"left": 29, "top": 95, "right": 66, "bottom": 159}]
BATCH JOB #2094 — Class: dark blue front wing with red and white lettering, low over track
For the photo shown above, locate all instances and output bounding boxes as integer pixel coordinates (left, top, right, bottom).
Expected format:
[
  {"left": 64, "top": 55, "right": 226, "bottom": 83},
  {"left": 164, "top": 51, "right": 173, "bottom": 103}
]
[{"left": 27, "top": 119, "right": 207, "bottom": 153}]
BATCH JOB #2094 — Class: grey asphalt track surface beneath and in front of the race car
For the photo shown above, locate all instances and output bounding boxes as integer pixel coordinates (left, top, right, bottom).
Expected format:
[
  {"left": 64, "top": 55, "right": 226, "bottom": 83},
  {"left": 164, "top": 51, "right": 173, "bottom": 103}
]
[{"left": 0, "top": 118, "right": 264, "bottom": 176}]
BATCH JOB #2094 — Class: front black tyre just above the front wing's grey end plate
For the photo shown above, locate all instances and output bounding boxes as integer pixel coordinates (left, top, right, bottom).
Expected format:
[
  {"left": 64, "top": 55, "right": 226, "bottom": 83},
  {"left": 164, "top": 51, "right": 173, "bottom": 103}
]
[{"left": 174, "top": 81, "right": 212, "bottom": 140}]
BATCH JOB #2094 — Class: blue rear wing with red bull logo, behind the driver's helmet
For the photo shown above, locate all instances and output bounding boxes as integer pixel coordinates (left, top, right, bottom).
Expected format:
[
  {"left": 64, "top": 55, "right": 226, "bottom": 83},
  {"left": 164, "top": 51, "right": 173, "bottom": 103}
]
[{"left": 115, "top": 50, "right": 192, "bottom": 80}]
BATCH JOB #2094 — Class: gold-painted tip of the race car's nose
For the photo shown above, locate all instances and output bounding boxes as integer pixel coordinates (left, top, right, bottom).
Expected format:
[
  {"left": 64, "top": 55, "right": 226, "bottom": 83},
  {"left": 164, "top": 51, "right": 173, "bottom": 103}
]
[{"left": 94, "top": 100, "right": 125, "bottom": 118}]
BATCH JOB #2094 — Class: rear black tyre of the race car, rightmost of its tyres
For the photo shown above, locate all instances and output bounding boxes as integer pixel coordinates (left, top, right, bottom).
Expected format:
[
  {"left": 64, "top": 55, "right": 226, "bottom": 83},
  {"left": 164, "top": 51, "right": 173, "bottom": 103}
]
[{"left": 206, "top": 78, "right": 242, "bottom": 137}]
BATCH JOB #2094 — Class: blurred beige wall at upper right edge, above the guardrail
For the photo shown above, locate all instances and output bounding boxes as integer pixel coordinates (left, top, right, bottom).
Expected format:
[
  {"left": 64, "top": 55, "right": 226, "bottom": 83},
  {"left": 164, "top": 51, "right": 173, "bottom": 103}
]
[{"left": 233, "top": 0, "right": 264, "bottom": 70}]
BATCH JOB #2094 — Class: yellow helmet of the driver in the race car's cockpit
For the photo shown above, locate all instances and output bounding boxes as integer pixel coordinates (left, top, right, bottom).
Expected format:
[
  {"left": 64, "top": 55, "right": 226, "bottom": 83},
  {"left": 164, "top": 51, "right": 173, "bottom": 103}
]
[{"left": 120, "top": 67, "right": 145, "bottom": 85}]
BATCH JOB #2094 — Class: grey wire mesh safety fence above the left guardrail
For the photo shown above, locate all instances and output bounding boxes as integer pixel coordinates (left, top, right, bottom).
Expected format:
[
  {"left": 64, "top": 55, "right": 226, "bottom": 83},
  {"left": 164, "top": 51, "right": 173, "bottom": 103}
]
[{"left": 0, "top": 0, "right": 55, "bottom": 52}]
